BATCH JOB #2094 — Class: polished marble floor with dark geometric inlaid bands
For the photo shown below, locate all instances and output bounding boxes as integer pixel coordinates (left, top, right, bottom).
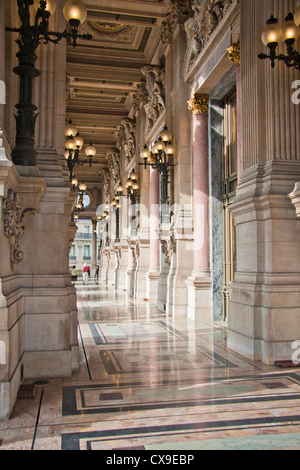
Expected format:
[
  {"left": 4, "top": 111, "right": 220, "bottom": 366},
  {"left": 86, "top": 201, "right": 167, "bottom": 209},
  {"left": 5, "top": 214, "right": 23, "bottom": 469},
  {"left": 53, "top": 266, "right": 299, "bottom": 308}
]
[{"left": 0, "top": 281, "right": 300, "bottom": 451}]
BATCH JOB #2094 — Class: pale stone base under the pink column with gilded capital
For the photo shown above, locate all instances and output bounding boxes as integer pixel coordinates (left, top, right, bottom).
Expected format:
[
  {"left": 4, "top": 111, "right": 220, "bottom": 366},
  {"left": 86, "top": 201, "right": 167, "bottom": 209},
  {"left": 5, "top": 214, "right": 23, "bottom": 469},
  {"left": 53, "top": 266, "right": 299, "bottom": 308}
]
[{"left": 186, "top": 274, "right": 213, "bottom": 323}]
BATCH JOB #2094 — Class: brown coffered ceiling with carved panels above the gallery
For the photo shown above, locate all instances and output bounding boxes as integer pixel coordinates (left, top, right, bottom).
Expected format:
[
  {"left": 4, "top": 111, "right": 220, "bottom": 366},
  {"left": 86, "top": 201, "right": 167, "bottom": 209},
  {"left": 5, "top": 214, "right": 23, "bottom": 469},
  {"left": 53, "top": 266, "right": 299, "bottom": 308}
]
[{"left": 66, "top": 0, "right": 167, "bottom": 183}]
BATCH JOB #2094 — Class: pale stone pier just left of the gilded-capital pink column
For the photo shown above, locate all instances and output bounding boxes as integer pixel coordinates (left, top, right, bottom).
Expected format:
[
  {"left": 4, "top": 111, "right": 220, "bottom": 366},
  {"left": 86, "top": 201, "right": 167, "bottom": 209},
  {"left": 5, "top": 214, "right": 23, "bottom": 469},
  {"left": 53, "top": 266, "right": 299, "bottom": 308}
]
[{"left": 162, "top": 24, "right": 193, "bottom": 317}]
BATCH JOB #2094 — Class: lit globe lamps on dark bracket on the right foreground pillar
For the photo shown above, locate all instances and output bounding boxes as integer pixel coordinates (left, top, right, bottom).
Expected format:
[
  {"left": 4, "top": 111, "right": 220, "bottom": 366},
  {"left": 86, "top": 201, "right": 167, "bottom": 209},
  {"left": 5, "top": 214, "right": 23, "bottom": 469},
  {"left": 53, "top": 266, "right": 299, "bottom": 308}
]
[{"left": 258, "top": 6, "right": 300, "bottom": 70}]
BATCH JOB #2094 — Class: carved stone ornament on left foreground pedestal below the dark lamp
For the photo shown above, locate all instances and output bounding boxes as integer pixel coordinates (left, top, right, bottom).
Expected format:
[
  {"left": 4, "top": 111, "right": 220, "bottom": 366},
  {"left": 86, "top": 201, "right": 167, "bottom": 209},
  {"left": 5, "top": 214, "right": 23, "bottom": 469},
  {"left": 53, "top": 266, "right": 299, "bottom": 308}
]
[{"left": 3, "top": 189, "right": 36, "bottom": 266}]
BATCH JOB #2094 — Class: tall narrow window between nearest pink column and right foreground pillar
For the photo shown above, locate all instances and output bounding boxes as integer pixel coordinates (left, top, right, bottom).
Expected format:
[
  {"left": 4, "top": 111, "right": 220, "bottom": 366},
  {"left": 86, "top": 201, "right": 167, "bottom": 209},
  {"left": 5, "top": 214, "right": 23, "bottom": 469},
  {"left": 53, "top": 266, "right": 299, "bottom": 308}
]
[{"left": 223, "top": 93, "right": 238, "bottom": 304}]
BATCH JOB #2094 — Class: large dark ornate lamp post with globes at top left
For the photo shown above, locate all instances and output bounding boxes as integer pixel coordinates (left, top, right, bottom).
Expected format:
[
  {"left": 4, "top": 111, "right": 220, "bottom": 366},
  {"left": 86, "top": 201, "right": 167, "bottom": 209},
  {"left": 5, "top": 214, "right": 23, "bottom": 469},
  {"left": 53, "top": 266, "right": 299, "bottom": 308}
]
[{"left": 6, "top": 0, "right": 92, "bottom": 166}]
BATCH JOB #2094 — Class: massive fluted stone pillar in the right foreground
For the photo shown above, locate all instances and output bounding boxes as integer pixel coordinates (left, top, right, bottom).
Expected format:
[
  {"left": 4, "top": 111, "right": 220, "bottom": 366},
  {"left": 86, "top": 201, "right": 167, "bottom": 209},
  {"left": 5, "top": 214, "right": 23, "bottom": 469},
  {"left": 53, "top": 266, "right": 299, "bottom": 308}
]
[{"left": 228, "top": 0, "right": 300, "bottom": 364}]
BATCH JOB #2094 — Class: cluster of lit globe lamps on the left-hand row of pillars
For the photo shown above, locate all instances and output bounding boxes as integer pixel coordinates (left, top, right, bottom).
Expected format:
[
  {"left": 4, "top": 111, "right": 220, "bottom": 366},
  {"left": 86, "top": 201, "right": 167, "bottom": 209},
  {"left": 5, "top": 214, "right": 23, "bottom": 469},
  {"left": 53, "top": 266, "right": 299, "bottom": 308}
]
[{"left": 65, "top": 119, "right": 96, "bottom": 181}]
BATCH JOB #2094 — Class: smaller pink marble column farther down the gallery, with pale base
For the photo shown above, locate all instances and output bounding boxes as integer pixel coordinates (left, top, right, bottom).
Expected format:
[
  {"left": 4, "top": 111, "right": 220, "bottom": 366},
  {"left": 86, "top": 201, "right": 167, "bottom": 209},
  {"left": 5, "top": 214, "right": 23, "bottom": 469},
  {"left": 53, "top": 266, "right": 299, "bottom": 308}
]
[{"left": 146, "top": 167, "right": 160, "bottom": 303}]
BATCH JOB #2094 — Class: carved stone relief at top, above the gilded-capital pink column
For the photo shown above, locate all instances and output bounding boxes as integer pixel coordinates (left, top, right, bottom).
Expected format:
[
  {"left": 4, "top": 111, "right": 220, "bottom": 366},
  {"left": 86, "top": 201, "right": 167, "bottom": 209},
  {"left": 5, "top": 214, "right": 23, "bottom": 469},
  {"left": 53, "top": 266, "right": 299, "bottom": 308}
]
[{"left": 185, "top": 0, "right": 232, "bottom": 69}]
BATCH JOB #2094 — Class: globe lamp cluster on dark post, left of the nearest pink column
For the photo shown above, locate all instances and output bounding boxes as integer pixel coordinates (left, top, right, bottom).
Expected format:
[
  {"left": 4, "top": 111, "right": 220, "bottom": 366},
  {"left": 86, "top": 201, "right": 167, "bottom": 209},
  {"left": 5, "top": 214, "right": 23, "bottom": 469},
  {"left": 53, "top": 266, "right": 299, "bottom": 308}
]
[{"left": 139, "top": 126, "right": 175, "bottom": 222}]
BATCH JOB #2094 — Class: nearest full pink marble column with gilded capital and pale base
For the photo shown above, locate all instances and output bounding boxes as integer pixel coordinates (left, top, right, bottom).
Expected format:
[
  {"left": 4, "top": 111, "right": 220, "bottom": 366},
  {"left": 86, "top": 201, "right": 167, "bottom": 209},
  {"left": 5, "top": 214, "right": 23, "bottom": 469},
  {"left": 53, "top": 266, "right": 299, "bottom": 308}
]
[{"left": 187, "top": 95, "right": 212, "bottom": 322}]
